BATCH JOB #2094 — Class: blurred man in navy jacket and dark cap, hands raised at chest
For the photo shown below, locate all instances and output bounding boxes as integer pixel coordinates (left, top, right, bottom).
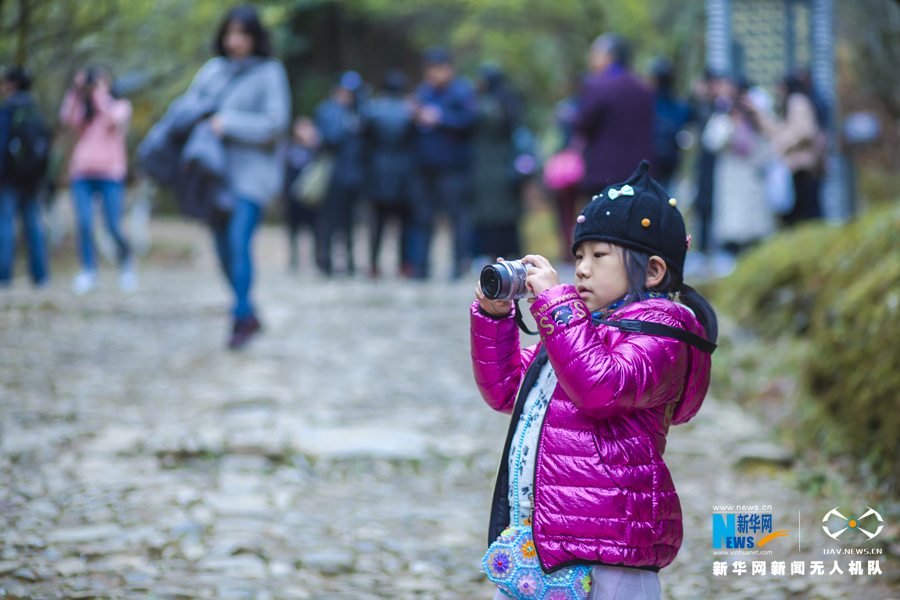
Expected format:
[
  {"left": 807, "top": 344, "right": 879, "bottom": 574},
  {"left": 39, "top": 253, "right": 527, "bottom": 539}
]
[{"left": 410, "top": 46, "right": 478, "bottom": 278}]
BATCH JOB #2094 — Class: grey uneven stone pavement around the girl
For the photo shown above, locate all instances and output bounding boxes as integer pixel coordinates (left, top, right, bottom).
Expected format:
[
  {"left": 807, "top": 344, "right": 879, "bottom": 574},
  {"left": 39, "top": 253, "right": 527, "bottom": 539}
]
[{"left": 0, "top": 222, "right": 900, "bottom": 600}]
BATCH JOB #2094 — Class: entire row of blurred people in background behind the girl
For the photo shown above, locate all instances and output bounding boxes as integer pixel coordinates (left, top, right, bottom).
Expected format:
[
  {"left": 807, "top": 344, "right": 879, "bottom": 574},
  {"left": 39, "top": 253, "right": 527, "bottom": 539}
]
[{"left": 0, "top": 6, "right": 828, "bottom": 348}]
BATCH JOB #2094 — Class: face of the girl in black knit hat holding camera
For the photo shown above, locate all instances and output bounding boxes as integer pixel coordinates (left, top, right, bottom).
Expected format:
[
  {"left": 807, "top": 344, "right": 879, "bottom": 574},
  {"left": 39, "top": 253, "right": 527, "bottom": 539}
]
[{"left": 575, "top": 240, "right": 629, "bottom": 312}]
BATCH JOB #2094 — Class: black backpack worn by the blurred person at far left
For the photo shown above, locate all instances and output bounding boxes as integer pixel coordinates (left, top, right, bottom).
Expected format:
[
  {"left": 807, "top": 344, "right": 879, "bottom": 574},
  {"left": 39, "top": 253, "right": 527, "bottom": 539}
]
[{"left": 6, "top": 104, "right": 50, "bottom": 184}]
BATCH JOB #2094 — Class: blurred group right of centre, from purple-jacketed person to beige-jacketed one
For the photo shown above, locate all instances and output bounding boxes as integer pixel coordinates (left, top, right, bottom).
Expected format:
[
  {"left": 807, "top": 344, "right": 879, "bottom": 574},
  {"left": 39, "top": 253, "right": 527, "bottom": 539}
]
[{"left": 544, "top": 34, "right": 828, "bottom": 275}]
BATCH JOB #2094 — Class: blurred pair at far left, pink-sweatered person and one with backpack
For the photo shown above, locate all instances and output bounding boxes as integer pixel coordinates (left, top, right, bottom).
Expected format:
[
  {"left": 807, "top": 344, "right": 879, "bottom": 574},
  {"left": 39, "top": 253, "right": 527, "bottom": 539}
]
[{"left": 0, "top": 62, "right": 137, "bottom": 294}]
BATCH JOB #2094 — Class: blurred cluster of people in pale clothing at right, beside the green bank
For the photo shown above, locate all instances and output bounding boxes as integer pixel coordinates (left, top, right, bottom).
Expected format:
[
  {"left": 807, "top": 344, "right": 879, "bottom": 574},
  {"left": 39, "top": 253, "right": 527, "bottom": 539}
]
[{"left": 693, "top": 69, "right": 828, "bottom": 275}]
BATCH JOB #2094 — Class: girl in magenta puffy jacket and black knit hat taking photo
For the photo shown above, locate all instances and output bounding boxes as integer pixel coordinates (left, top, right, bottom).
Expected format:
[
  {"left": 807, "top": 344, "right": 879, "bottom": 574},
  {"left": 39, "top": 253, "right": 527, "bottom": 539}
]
[{"left": 471, "top": 161, "right": 717, "bottom": 600}]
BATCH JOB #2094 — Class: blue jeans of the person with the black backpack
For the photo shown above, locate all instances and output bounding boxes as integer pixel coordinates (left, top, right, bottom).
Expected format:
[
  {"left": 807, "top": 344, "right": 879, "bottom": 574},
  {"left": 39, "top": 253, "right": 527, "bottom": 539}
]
[{"left": 0, "top": 184, "right": 49, "bottom": 285}]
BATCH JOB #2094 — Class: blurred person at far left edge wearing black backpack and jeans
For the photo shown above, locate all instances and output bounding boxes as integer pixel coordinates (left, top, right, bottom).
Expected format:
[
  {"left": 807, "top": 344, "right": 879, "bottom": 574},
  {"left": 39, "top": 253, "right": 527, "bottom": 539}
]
[{"left": 0, "top": 67, "right": 50, "bottom": 287}]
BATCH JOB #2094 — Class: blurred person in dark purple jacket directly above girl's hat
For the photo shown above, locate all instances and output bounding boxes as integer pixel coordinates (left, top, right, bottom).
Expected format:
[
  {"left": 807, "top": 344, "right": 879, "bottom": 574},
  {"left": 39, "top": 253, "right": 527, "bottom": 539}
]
[{"left": 573, "top": 33, "right": 654, "bottom": 195}]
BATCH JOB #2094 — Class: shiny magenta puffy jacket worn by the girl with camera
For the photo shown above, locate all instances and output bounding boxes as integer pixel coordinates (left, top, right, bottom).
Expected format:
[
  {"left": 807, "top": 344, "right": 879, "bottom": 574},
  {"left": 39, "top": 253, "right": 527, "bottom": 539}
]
[{"left": 471, "top": 285, "right": 711, "bottom": 573}]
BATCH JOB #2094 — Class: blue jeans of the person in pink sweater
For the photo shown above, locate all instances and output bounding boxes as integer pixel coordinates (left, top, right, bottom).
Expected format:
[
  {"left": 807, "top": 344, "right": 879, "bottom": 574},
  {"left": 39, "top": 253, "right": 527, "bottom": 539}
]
[{"left": 72, "top": 179, "right": 131, "bottom": 271}]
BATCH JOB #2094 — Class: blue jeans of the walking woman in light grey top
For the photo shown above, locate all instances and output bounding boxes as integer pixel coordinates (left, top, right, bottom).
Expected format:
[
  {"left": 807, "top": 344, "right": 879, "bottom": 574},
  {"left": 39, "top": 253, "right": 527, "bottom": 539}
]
[{"left": 213, "top": 198, "right": 260, "bottom": 320}]
